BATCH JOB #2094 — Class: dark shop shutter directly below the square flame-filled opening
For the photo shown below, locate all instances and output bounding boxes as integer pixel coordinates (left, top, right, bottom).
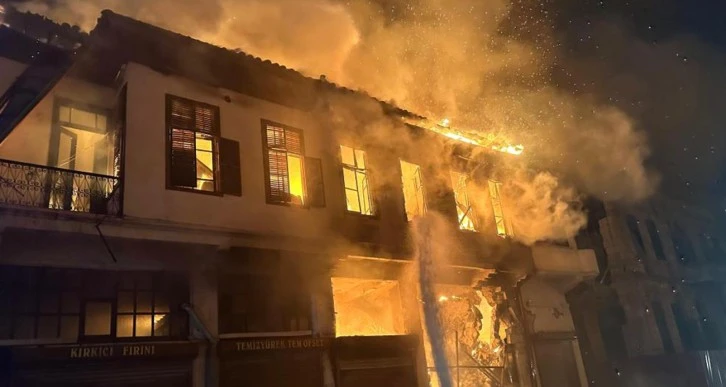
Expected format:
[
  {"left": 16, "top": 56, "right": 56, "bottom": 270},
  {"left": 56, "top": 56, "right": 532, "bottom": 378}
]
[{"left": 333, "top": 336, "right": 419, "bottom": 387}]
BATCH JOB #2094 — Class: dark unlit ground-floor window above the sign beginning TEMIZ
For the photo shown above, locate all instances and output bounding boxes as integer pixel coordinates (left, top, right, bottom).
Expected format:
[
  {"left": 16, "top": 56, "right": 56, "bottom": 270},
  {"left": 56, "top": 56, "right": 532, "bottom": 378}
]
[{"left": 219, "top": 270, "right": 312, "bottom": 333}]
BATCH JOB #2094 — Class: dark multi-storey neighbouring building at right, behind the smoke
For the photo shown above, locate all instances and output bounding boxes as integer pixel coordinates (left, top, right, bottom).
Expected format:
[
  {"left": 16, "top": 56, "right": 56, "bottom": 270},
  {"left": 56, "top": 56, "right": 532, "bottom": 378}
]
[{"left": 569, "top": 197, "right": 726, "bottom": 387}]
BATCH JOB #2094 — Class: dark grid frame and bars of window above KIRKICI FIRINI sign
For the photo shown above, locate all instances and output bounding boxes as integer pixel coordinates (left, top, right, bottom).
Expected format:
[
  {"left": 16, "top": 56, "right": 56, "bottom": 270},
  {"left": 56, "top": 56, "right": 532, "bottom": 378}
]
[{"left": 0, "top": 264, "right": 190, "bottom": 343}]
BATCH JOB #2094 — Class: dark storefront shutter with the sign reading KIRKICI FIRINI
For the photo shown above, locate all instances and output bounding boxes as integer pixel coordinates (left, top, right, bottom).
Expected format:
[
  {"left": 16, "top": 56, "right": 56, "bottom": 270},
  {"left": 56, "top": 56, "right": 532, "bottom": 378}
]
[{"left": 4, "top": 342, "right": 199, "bottom": 387}]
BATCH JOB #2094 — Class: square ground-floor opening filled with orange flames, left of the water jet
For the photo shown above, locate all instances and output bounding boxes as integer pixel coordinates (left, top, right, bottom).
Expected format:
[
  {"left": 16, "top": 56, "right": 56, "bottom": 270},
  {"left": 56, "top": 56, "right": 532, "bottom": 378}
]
[{"left": 332, "top": 278, "right": 406, "bottom": 337}]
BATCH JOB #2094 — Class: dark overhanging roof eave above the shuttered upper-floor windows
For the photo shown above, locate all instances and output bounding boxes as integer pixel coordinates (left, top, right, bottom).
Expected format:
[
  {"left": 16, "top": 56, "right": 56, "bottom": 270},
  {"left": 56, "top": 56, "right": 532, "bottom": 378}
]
[{"left": 82, "top": 10, "right": 422, "bottom": 118}]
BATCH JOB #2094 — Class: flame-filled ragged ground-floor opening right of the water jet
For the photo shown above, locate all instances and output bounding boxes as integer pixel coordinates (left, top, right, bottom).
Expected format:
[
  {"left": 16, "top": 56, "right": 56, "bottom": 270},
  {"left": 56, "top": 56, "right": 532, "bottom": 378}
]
[{"left": 422, "top": 285, "right": 505, "bottom": 387}]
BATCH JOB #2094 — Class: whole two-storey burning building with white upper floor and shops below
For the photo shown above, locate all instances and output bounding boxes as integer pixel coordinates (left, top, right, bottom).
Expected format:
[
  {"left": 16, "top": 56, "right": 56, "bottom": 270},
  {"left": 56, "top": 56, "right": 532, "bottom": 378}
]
[{"left": 0, "top": 11, "right": 598, "bottom": 387}]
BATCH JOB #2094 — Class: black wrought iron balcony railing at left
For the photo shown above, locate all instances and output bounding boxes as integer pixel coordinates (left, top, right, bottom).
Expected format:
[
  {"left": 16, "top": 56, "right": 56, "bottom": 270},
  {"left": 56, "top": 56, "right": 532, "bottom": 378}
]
[{"left": 0, "top": 159, "right": 121, "bottom": 216}]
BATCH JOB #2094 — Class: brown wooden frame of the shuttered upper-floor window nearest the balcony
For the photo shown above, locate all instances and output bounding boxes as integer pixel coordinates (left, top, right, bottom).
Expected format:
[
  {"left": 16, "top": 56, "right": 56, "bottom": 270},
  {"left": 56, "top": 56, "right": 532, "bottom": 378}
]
[{"left": 164, "top": 94, "right": 224, "bottom": 196}]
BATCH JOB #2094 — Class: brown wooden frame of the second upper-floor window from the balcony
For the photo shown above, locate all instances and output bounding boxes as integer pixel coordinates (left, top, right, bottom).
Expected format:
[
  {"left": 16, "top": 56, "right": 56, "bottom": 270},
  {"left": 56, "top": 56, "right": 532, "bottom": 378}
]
[{"left": 260, "top": 119, "right": 310, "bottom": 209}]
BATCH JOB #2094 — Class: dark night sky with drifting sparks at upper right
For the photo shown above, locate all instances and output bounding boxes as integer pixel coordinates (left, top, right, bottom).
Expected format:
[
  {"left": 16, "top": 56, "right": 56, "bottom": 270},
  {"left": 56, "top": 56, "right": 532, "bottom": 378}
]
[{"left": 544, "top": 0, "right": 726, "bottom": 209}]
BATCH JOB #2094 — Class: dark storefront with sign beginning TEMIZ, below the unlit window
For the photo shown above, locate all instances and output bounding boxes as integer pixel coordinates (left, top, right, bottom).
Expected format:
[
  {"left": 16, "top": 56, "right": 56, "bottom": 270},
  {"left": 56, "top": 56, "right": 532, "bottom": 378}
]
[{"left": 218, "top": 336, "right": 330, "bottom": 387}]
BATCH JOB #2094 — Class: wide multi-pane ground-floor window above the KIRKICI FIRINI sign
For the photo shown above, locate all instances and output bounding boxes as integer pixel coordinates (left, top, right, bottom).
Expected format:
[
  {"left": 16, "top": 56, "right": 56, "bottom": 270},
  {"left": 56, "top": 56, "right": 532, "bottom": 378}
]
[{"left": 0, "top": 266, "right": 189, "bottom": 342}]
